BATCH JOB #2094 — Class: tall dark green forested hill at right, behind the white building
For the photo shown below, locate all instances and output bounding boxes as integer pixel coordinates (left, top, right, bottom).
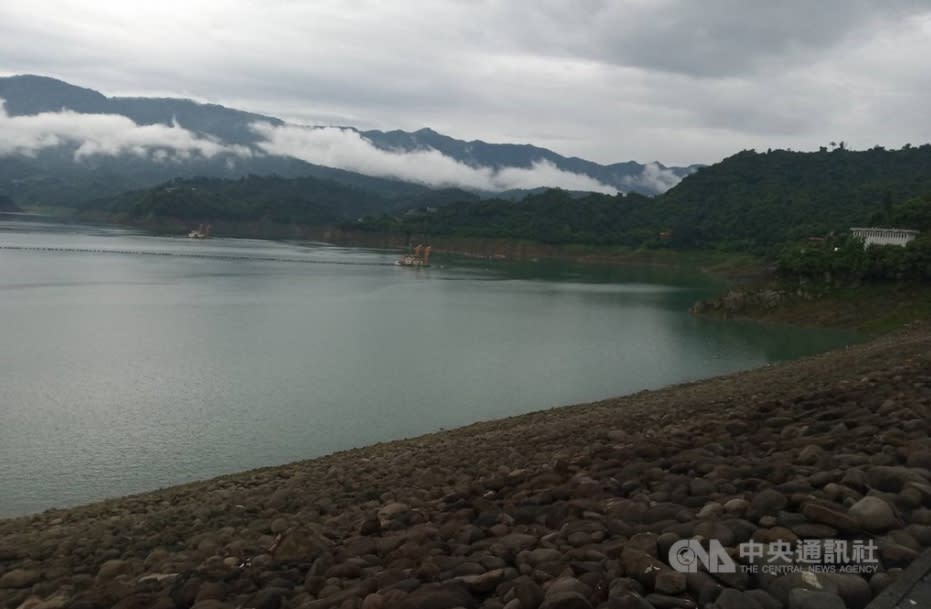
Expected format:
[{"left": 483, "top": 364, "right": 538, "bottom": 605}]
[{"left": 658, "top": 144, "right": 931, "bottom": 249}]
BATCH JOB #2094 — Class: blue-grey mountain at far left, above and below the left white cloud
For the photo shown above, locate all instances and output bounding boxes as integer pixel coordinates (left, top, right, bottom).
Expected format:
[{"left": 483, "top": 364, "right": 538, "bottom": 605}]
[{"left": 0, "top": 76, "right": 446, "bottom": 211}]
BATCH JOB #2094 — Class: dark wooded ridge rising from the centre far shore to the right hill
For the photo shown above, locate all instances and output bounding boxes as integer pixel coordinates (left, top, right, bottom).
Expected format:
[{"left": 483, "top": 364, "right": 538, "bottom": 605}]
[{"left": 356, "top": 144, "right": 931, "bottom": 253}]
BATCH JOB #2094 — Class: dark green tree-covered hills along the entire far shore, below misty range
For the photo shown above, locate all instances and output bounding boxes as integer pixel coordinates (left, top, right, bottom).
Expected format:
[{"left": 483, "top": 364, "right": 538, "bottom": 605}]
[{"left": 90, "top": 145, "right": 931, "bottom": 278}]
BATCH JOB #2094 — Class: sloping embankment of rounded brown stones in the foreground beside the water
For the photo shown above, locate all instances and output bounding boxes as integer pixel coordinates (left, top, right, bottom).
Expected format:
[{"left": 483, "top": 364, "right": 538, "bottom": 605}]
[{"left": 0, "top": 329, "right": 931, "bottom": 609}]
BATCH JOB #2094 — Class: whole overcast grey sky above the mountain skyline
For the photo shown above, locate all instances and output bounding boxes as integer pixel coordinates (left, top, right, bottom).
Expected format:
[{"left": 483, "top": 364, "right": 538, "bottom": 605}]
[{"left": 0, "top": 0, "right": 931, "bottom": 164}]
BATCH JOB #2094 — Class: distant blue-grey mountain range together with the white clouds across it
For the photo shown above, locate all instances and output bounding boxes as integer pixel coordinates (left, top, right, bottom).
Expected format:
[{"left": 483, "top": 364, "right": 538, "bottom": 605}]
[{"left": 0, "top": 75, "right": 695, "bottom": 204}]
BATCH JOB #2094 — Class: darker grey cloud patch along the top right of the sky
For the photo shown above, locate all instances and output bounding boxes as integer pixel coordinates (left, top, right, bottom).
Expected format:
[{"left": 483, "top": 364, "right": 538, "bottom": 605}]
[{"left": 507, "top": 0, "right": 928, "bottom": 77}]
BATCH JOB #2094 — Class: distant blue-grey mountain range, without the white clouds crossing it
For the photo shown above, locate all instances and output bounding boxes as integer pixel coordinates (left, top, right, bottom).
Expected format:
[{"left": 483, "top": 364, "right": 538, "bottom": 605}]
[{"left": 0, "top": 75, "right": 696, "bottom": 203}]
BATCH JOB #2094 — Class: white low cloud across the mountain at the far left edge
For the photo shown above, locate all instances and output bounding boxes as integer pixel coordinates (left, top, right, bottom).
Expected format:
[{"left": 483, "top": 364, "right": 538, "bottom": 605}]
[{"left": 0, "top": 100, "right": 252, "bottom": 161}]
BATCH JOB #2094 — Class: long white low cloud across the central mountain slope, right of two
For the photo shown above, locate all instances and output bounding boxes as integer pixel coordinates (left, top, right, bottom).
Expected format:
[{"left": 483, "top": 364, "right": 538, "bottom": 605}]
[{"left": 252, "top": 123, "right": 617, "bottom": 194}]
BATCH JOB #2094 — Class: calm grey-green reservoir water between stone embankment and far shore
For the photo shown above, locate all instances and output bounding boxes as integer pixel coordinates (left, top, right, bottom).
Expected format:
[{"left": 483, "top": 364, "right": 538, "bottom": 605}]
[{"left": 0, "top": 216, "right": 858, "bottom": 516}]
